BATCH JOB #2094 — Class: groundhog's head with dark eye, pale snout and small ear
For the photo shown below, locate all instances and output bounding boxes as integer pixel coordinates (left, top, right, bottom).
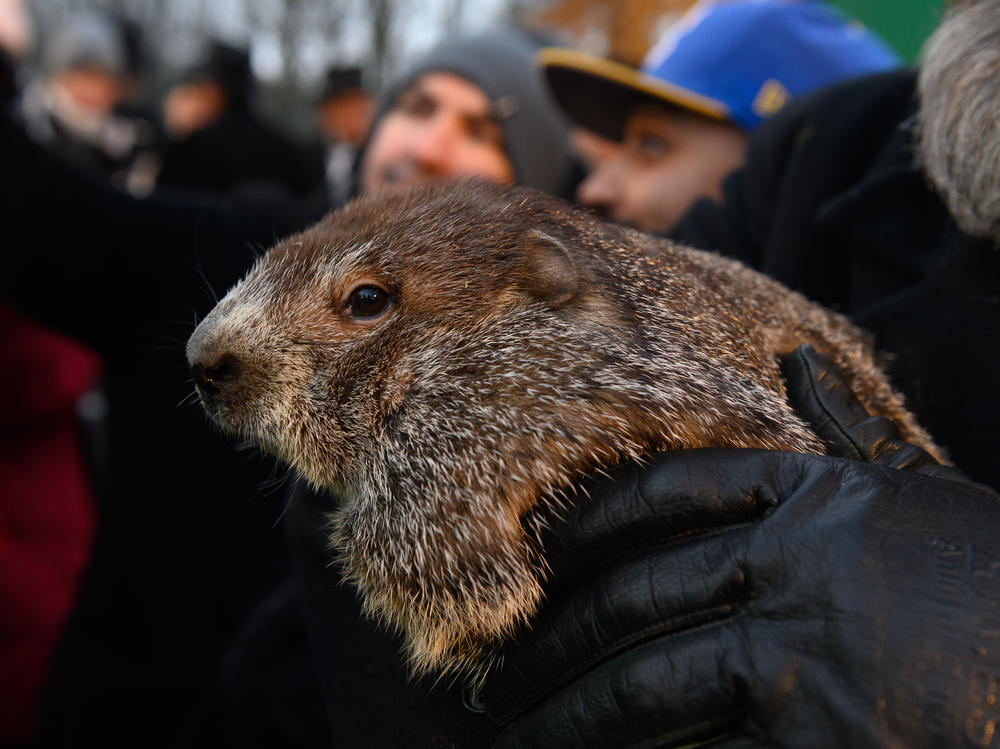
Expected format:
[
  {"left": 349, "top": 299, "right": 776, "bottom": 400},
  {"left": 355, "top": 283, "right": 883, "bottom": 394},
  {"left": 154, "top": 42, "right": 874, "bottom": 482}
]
[{"left": 187, "top": 182, "right": 620, "bottom": 486}]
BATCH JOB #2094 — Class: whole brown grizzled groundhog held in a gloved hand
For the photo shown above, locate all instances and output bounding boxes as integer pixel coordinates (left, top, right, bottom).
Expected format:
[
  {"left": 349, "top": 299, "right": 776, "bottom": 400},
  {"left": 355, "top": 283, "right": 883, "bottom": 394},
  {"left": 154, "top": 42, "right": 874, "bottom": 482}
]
[{"left": 187, "top": 181, "right": 943, "bottom": 675}]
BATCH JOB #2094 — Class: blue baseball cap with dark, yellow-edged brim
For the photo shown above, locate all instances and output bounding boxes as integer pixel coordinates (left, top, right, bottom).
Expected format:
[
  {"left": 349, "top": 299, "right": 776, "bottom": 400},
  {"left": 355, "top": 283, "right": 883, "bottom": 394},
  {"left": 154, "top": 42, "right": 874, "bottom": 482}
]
[{"left": 538, "top": 0, "right": 900, "bottom": 140}]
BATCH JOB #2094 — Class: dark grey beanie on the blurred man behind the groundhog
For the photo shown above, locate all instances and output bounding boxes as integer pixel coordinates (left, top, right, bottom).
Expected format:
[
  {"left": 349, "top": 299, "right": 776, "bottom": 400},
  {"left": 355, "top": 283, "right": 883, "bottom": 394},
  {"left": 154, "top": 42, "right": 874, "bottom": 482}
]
[{"left": 376, "top": 28, "right": 571, "bottom": 194}]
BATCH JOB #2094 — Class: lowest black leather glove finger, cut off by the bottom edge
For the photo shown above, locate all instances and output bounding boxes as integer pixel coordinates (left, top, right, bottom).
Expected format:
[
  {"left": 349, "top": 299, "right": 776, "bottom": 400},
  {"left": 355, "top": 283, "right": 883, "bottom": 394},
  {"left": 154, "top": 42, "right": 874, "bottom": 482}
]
[{"left": 487, "top": 620, "right": 746, "bottom": 749}]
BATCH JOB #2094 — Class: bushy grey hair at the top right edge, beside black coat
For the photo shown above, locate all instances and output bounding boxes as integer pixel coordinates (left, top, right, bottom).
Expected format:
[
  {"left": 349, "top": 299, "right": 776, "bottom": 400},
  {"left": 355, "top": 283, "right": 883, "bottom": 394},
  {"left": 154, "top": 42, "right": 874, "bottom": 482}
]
[{"left": 919, "top": 0, "right": 1000, "bottom": 242}]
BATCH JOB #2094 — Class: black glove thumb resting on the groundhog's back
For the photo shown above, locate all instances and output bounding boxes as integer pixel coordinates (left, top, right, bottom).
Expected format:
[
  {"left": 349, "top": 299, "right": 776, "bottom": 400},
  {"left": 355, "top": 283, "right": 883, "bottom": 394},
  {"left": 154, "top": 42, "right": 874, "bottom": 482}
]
[{"left": 782, "top": 345, "right": 940, "bottom": 469}]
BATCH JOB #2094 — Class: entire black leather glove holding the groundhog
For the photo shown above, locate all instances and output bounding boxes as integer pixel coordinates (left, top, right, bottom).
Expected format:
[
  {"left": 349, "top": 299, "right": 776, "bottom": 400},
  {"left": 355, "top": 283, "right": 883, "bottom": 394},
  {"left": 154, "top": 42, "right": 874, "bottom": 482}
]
[{"left": 482, "top": 349, "right": 1000, "bottom": 749}]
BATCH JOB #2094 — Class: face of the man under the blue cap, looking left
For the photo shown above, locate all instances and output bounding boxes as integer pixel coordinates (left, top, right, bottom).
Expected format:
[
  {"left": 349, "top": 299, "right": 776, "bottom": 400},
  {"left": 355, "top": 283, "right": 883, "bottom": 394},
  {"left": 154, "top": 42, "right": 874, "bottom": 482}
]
[{"left": 577, "top": 104, "right": 746, "bottom": 232}]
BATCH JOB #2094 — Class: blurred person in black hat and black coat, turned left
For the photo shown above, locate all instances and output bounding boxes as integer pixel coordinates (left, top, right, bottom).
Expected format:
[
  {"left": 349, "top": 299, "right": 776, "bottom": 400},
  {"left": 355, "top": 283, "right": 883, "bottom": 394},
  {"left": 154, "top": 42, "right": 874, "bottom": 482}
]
[{"left": 156, "top": 41, "right": 324, "bottom": 198}]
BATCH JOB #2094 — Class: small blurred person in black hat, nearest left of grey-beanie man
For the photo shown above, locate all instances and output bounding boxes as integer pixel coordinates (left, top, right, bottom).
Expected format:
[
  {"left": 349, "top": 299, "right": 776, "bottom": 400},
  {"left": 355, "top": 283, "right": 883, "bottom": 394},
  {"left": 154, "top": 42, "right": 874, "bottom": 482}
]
[{"left": 316, "top": 67, "right": 373, "bottom": 207}]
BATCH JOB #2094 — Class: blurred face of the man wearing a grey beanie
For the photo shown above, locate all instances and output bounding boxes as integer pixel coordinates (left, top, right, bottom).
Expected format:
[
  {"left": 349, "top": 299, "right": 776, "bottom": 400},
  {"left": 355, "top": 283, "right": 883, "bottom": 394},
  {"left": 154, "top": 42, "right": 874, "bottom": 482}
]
[{"left": 361, "top": 73, "right": 514, "bottom": 193}]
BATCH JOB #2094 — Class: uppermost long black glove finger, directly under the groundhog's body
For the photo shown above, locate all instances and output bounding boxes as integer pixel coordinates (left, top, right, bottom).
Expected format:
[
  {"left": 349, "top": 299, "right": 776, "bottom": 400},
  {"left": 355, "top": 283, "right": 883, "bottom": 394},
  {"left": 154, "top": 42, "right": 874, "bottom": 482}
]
[{"left": 544, "top": 449, "right": 801, "bottom": 582}]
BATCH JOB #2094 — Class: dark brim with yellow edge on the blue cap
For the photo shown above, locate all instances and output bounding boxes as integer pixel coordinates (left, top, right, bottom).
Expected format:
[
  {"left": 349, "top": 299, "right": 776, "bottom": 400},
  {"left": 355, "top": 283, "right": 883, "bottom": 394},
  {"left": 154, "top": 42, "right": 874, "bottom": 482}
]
[{"left": 536, "top": 47, "right": 729, "bottom": 141}]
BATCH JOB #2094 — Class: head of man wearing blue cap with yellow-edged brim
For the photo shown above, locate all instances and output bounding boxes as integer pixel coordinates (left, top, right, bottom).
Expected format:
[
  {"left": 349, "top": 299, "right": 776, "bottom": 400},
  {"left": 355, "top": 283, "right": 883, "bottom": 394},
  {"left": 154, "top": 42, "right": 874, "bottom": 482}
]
[{"left": 539, "top": 0, "right": 899, "bottom": 233}]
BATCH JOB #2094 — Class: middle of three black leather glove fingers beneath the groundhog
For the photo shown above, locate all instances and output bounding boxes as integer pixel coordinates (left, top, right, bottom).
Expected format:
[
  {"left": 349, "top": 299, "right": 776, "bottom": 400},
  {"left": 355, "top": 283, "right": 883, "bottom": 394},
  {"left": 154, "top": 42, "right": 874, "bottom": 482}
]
[{"left": 486, "top": 529, "right": 750, "bottom": 718}]
